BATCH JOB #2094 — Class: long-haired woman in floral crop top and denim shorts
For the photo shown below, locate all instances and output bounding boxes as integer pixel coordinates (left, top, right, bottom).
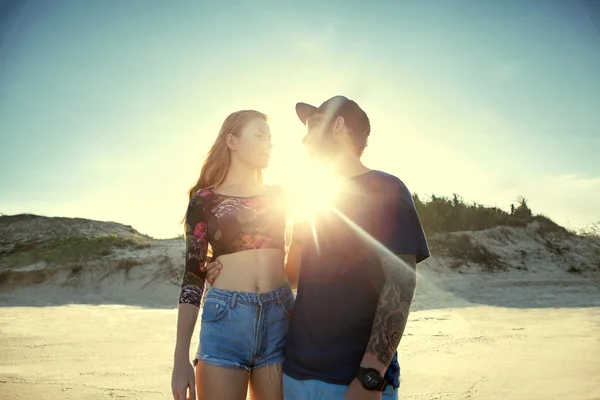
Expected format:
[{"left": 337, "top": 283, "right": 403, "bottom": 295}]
[{"left": 172, "top": 110, "right": 294, "bottom": 400}]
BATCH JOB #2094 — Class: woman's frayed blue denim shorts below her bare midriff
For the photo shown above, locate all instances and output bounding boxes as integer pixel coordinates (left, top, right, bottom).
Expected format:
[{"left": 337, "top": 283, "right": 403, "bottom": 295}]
[{"left": 196, "top": 284, "right": 294, "bottom": 371}]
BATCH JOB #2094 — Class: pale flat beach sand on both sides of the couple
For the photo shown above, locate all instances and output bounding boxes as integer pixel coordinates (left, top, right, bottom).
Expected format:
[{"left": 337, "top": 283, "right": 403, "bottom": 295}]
[{"left": 0, "top": 265, "right": 600, "bottom": 400}]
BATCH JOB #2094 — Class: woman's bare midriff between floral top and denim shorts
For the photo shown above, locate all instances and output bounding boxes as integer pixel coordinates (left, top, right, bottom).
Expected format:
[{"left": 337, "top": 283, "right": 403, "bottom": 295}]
[{"left": 213, "top": 249, "right": 287, "bottom": 293}]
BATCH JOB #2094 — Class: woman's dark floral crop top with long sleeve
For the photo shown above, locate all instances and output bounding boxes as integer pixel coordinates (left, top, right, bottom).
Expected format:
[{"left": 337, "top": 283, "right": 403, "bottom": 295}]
[{"left": 179, "top": 187, "right": 285, "bottom": 307}]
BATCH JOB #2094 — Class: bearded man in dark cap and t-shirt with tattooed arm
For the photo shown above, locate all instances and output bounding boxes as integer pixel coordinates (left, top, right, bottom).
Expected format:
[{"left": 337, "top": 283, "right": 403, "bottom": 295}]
[{"left": 208, "top": 96, "right": 429, "bottom": 400}]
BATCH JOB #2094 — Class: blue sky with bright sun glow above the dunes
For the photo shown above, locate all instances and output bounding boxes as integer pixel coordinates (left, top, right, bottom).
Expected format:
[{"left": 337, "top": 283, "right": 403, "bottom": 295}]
[{"left": 0, "top": 0, "right": 600, "bottom": 237}]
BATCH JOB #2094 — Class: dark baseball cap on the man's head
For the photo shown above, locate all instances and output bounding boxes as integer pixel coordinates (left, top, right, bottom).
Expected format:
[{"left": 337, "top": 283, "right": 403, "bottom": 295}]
[{"left": 296, "top": 96, "right": 371, "bottom": 136}]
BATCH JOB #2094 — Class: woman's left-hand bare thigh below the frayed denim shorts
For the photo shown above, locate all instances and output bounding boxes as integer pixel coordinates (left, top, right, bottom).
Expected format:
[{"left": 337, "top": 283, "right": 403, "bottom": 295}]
[{"left": 196, "top": 361, "right": 249, "bottom": 400}]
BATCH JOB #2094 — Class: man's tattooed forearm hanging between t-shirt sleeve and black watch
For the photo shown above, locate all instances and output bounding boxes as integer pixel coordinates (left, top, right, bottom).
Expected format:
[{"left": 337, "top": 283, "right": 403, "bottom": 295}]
[{"left": 367, "top": 255, "right": 416, "bottom": 366}]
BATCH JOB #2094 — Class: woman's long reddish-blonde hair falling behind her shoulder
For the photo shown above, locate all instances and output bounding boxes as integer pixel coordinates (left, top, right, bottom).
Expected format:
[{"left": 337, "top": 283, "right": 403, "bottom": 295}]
[{"left": 188, "top": 110, "right": 268, "bottom": 198}]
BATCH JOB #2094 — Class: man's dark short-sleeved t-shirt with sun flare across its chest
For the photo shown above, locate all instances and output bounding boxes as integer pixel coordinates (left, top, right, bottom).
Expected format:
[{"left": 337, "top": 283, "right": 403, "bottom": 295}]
[{"left": 283, "top": 171, "right": 429, "bottom": 387}]
